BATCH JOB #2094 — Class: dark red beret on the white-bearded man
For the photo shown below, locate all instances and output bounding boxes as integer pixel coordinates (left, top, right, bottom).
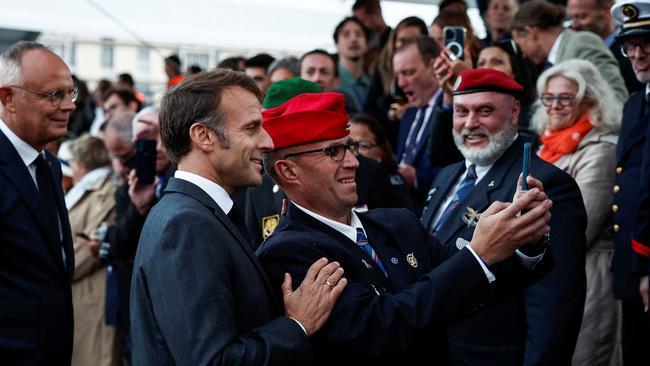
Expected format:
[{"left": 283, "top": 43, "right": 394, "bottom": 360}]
[{"left": 454, "top": 69, "right": 524, "bottom": 98}]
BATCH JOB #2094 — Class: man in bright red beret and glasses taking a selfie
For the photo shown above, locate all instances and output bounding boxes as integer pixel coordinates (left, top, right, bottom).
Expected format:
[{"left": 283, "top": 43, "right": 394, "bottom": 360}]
[{"left": 258, "top": 93, "right": 550, "bottom": 365}]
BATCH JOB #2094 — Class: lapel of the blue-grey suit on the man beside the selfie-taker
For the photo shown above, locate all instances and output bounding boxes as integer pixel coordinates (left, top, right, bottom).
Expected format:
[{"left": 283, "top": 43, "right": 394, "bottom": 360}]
[{"left": 165, "top": 178, "right": 282, "bottom": 307}]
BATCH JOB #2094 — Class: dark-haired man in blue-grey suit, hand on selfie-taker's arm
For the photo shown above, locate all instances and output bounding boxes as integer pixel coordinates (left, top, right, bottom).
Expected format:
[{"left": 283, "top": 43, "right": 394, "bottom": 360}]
[{"left": 131, "top": 70, "right": 346, "bottom": 365}]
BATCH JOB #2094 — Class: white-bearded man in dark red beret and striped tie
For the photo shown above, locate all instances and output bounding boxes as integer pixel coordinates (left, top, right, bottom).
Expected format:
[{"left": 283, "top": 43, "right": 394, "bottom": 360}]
[{"left": 422, "top": 69, "right": 587, "bottom": 365}]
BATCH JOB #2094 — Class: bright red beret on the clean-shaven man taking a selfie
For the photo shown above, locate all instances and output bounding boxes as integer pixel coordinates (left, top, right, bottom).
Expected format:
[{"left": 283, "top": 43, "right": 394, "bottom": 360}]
[{"left": 262, "top": 93, "right": 350, "bottom": 149}]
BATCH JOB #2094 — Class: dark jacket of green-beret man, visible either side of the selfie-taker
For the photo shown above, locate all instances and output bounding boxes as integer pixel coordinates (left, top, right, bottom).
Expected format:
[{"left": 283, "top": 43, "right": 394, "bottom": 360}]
[{"left": 243, "top": 155, "right": 411, "bottom": 248}]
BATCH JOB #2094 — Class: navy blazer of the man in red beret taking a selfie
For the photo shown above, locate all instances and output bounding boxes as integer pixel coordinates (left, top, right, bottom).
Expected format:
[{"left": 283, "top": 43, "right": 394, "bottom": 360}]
[{"left": 257, "top": 204, "right": 544, "bottom": 365}]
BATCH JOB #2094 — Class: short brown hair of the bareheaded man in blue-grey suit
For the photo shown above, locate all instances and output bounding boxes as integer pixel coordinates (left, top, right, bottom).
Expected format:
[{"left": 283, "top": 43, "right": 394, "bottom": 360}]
[{"left": 158, "top": 69, "right": 263, "bottom": 164}]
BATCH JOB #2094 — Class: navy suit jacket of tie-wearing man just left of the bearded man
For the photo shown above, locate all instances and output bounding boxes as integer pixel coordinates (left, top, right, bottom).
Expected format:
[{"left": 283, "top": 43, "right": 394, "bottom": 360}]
[{"left": 395, "top": 105, "right": 443, "bottom": 202}]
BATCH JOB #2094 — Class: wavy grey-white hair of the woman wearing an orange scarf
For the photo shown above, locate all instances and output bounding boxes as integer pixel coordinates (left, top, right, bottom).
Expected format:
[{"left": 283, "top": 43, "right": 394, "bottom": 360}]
[{"left": 531, "top": 59, "right": 623, "bottom": 134}]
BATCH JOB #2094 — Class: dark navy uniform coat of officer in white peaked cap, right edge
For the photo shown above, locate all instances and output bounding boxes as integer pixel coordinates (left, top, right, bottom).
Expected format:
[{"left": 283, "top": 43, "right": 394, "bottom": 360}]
[{"left": 612, "top": 91, "right": 649, "bottom": 306}]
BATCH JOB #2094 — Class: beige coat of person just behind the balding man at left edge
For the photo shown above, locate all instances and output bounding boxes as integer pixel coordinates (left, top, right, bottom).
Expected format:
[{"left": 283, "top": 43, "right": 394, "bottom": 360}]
[{"left": 69, "top": 170, "right": 121, "bottom": 366}]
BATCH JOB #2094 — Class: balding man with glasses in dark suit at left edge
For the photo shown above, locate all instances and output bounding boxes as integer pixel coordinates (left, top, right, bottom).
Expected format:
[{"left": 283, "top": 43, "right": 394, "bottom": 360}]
[{"left": 0, "top": 42, "right": 78, "bottom": 365}]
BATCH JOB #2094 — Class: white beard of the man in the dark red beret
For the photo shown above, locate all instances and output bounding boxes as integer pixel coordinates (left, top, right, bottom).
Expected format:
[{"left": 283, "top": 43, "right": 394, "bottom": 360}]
[{"left": 452, "top": 121, "right": 517, "bottom": 166}]
